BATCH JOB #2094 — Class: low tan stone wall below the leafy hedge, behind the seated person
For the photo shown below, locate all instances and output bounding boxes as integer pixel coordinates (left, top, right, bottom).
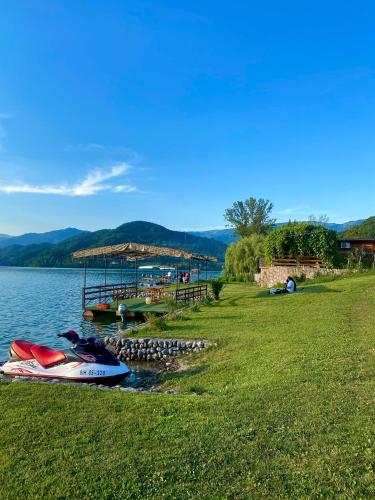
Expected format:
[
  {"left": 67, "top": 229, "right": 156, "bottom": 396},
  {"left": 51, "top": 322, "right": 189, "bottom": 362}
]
[{"left": 258, "top": 266, "right": 347, "bottom": 288}]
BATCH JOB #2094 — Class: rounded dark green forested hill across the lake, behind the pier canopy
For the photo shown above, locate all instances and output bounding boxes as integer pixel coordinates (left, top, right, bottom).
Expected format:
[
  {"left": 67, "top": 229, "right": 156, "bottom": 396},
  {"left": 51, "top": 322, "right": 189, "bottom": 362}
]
[{"left": 0, "top": 221, "right": 226, "bottom": 267}]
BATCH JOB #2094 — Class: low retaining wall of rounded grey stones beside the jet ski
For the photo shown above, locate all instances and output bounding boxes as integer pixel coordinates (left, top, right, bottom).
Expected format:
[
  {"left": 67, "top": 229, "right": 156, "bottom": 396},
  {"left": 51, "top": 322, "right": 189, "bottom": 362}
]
[{"left": 105, "top": 337, "right": 208, "bottom": 361}]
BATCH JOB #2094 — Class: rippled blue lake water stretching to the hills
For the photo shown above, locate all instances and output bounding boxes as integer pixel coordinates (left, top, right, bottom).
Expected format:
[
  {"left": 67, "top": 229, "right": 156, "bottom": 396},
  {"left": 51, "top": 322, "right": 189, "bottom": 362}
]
[{"left": 0, "top": 267, "right": 220, "bottom": 361}]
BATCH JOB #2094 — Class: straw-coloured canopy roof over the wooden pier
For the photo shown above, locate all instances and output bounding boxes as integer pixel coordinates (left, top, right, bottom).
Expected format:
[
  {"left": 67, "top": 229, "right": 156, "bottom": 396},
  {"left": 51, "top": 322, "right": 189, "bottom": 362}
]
[{"left": 73, "top": 243, "right": 217, "bottom": 262}]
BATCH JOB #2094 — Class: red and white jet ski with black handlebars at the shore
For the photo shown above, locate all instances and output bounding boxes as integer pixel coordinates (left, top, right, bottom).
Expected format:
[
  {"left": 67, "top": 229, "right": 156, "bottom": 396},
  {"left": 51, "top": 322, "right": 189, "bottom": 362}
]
[{"left": 0, "top": 330, "right": 131, "bottom": 385}]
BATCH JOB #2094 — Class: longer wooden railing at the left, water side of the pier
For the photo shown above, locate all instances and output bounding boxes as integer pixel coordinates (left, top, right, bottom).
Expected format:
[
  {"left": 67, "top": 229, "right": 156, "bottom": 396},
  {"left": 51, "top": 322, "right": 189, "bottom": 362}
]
[{"left": 82, "top": 283, "right": 138, "bottom": 309}]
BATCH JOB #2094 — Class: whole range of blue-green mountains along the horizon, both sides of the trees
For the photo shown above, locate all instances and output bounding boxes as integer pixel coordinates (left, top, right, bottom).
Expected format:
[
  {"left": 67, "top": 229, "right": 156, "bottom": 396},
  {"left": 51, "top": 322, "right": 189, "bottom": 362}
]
[{"left": 0, "top": 217, "right": 375, "bottom": 267}]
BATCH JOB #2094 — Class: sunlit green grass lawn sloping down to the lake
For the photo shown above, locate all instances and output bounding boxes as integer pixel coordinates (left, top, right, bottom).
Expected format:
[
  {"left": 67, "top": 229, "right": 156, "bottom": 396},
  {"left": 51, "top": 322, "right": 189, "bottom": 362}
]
[{"left": 0, "top": 276, "right": 375, "bottom": 499}]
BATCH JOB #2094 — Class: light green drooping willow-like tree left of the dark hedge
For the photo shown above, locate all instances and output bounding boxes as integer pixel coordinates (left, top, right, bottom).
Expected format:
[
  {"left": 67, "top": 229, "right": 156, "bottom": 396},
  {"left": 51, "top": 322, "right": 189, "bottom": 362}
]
[{"left": 225, "top": 234, "right": 264, "bottom": 281}]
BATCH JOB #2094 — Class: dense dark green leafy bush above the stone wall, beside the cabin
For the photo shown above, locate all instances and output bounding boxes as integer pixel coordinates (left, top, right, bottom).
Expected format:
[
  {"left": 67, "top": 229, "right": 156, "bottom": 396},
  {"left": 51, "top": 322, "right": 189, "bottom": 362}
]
[{"left": 264, "top": 223, "right": 340, "bottom": 267}]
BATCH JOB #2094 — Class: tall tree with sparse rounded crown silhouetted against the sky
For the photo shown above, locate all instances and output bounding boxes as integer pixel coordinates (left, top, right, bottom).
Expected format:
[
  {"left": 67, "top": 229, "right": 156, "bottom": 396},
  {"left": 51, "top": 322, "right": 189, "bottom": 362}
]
[{"left": 224, "top": 198, "right": 276, "bottom": 238}]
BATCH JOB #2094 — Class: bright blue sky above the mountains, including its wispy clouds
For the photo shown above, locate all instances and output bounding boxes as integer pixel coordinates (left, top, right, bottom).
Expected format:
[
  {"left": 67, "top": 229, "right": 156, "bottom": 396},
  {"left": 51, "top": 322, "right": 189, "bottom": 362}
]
[{"left": 0, "top": 0, "right": 375, "bottom": 234}]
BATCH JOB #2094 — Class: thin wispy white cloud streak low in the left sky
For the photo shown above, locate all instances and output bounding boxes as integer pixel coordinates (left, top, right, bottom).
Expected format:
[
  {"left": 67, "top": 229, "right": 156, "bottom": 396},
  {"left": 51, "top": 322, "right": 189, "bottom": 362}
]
[{"left": 0, "top": 163, "right": 136, "bottom": 196}]
